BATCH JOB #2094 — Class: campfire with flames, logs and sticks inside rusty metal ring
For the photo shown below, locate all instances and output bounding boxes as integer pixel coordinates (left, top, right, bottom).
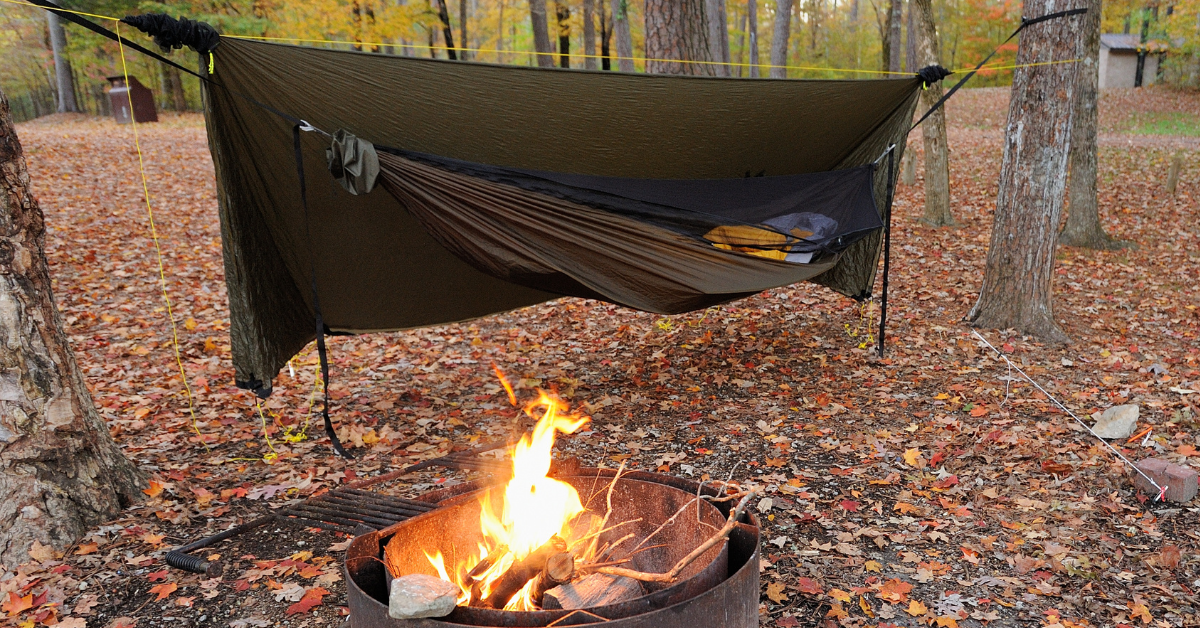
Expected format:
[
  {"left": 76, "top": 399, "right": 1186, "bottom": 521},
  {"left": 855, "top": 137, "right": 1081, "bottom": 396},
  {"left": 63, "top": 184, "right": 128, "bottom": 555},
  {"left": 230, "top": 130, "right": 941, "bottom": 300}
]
[{"left": 347, "top": 379, "right": 758, "bottom": 627}]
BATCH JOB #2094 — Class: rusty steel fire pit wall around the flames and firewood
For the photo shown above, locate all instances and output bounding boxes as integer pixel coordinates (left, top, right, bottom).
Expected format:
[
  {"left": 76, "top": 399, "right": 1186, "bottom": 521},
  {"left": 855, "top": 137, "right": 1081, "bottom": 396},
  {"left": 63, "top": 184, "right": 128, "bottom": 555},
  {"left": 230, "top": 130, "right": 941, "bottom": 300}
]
[{"left": 346, "top": 468, "right": 758, "bottom": 628}]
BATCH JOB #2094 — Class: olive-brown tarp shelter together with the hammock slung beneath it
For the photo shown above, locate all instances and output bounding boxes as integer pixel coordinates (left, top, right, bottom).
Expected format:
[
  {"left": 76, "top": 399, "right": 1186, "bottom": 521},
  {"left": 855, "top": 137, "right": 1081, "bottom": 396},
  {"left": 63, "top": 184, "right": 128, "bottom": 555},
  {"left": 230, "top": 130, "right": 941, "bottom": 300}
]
[{"left": 196, "top": 38, "right": 922, "bottom": 393}]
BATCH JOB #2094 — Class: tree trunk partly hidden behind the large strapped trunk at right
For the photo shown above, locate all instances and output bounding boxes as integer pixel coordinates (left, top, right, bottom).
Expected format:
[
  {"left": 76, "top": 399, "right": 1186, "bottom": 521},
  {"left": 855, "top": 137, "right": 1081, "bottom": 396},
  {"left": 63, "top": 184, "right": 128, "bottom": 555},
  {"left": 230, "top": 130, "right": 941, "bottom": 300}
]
[{"left": 1058, "top": 0, "right": 1129, "bottom": 250}]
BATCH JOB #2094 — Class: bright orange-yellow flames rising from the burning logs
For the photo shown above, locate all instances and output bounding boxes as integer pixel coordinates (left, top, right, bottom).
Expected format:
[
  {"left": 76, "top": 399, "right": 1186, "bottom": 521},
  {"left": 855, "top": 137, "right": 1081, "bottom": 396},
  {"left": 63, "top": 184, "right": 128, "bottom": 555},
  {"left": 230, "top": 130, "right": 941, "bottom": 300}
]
[{"left": 426, "top": 366, "right": 590, "bottom": 610}]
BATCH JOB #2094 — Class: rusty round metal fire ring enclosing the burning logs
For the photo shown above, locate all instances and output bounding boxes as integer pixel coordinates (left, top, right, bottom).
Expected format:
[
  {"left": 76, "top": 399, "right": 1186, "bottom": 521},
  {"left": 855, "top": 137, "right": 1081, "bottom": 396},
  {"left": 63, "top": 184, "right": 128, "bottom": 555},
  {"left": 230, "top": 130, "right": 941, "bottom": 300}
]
[{"left": 346, "top": 468, "right": 758, "bottom": 628}]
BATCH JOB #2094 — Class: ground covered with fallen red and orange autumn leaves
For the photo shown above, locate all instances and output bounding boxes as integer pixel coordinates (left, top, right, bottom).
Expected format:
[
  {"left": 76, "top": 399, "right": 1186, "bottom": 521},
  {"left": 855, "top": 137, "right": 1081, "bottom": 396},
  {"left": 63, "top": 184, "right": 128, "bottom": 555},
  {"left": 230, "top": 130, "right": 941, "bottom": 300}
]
[{"left": 0, "top": 88, "right": 1200, "bottom": 628}]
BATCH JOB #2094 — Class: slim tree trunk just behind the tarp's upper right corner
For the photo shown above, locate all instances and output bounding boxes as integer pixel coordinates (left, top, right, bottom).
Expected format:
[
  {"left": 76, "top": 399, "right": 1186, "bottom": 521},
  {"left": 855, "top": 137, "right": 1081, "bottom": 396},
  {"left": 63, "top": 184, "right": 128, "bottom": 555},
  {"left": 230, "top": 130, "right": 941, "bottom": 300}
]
[{"left": 912, "top": 0, "right": 954, "bottom": 227}]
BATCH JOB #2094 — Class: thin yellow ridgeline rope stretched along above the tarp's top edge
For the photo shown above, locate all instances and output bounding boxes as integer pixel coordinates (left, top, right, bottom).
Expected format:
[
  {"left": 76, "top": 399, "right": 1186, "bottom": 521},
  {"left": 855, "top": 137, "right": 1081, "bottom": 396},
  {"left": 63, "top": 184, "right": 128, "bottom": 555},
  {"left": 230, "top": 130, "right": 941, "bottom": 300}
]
[{"left": 0, "top": 0, "right": 1080, "bottom": 77}]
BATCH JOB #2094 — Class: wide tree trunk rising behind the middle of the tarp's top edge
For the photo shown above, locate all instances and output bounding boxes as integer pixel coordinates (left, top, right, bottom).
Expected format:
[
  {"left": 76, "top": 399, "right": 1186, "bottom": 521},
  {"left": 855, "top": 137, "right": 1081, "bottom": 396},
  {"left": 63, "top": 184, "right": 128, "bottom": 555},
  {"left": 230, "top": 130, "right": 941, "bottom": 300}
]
[{"left": 646, "top": 0, "right": 716, "bottom": 76}]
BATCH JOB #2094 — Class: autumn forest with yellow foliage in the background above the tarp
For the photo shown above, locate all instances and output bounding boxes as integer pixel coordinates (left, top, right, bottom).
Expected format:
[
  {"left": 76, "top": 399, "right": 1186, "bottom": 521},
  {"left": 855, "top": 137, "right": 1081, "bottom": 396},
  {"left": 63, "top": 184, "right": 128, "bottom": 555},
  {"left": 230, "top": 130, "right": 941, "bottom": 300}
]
[{"left": 0, "top": 0, "right": 1200, "bottom": 120}]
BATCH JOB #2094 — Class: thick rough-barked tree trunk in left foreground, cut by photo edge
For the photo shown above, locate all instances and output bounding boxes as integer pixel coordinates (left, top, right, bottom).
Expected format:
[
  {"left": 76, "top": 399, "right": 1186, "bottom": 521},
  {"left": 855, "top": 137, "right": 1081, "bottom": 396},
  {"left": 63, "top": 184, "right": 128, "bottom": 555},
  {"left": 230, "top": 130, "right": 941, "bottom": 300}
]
[{"left": 0, "top": 84, "right": 145, "bottom": 568}]
